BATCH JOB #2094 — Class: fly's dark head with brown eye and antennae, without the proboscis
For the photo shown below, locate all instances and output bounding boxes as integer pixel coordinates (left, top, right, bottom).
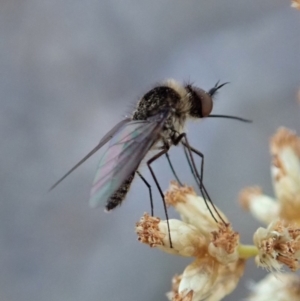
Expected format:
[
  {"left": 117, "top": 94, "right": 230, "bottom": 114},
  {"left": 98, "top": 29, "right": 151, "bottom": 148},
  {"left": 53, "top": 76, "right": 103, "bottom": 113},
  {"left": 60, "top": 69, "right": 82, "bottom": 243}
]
[{"left": 185, "top": 82, "right": 228, "bottom": 118}]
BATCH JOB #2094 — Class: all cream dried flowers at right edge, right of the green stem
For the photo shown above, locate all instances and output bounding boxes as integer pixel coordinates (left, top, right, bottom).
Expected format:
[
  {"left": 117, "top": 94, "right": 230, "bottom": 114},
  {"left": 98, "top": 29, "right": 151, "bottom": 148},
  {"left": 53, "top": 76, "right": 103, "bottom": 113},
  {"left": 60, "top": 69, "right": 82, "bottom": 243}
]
[{"left": 240, "top": 128, "right": 300, "bottom": 301}]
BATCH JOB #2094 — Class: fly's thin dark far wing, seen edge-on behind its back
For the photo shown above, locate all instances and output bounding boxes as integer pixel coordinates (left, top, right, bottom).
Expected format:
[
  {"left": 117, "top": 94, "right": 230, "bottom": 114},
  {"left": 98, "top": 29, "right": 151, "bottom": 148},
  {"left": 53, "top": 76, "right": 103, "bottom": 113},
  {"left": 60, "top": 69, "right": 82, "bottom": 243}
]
[{"left": 49, "top": 118, "right": 131, "bottom": 191}]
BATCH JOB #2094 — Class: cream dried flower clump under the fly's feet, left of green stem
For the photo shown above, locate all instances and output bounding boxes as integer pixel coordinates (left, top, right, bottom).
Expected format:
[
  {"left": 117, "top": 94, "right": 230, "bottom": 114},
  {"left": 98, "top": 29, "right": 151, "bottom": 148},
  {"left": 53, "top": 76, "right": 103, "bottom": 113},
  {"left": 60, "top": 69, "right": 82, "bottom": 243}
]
[{"left": 136, "top": 182, "right": 245, "bottom": 301}]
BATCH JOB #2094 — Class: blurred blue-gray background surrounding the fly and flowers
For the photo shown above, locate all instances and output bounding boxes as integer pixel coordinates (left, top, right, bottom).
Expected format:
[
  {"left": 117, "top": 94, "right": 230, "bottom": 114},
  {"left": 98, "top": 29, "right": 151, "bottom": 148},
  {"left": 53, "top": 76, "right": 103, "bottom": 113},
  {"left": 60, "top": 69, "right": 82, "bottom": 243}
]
[{"left": 0, "top": 0, "right": 300, "bottom": 301}]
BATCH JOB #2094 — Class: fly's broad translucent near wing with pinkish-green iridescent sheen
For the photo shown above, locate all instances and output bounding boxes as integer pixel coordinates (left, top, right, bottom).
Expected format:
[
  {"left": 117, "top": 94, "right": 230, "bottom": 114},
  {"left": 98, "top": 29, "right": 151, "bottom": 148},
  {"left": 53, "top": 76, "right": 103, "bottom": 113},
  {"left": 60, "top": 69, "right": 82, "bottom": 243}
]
[{"left": 90, "top": 110, "right": 169, "bottom": 207}]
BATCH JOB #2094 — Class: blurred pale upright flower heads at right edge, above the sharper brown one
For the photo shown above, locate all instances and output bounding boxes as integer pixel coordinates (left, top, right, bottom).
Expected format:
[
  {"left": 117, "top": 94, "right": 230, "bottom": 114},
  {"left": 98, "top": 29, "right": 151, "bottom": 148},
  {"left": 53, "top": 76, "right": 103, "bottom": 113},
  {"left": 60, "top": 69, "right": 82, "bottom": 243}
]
[{"left": 240, "top": 128, "right": 300, "bottom": 224}]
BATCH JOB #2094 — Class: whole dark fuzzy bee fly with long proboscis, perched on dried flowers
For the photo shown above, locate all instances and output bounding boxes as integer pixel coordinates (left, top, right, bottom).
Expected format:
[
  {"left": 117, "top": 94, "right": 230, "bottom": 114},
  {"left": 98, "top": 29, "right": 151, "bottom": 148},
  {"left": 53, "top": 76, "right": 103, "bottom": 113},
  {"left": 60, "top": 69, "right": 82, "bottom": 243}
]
[{"left": 50, "top": 79, "right": 249, "bottom": 245}]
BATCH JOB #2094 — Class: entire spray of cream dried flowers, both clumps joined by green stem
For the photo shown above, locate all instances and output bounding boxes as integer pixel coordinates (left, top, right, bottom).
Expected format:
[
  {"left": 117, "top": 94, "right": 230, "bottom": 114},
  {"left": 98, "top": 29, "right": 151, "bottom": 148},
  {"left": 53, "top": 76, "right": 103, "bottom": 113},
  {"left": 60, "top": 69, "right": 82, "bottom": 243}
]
[{"left": 136, "top": 128, "right": 300, "bottom": 301}]
